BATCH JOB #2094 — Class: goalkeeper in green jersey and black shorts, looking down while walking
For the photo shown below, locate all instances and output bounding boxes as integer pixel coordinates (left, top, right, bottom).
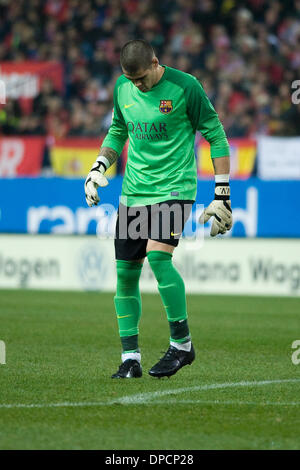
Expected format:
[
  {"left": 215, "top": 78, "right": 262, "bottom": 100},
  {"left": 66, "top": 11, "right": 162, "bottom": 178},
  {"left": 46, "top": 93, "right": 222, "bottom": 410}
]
[{"left": 85, "top": 40, "right": 232, "bottom": 378}]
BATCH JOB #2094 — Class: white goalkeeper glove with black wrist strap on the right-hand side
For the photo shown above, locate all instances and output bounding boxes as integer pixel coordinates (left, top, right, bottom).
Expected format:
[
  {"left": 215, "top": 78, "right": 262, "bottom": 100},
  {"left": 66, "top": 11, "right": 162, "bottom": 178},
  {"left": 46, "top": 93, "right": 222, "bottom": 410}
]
[{"left": 199, "top": 183, "right": 232, "bottom": 237}]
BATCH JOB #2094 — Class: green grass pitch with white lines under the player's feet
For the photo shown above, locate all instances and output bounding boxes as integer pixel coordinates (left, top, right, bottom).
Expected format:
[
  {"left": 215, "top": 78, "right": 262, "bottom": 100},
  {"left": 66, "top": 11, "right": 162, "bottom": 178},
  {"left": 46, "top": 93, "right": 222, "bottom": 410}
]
[{"left": 0, "top": 290, "right": 300, "bottom": 450}]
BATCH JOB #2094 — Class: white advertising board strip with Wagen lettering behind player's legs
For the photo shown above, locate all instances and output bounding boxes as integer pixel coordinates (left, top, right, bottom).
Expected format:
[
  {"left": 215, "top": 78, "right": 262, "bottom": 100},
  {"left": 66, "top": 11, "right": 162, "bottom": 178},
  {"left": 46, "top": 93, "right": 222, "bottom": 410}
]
[{"left": 0, "top": 235, "right": 300, "bottom": 296}]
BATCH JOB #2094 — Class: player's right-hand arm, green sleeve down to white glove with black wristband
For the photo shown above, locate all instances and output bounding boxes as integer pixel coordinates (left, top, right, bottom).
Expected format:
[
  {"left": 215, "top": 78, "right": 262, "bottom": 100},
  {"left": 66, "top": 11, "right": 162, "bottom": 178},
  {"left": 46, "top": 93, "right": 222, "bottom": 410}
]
[{"left": 187, "top": 80, "right": 232, "bottom": 237}]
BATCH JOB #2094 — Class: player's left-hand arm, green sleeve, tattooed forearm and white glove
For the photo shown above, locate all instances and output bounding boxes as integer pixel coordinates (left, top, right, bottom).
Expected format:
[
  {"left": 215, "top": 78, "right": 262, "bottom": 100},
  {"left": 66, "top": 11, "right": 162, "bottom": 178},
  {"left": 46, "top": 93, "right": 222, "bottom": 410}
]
[{"left": 84, "top": 80, "right": 128, "bottom": 207}]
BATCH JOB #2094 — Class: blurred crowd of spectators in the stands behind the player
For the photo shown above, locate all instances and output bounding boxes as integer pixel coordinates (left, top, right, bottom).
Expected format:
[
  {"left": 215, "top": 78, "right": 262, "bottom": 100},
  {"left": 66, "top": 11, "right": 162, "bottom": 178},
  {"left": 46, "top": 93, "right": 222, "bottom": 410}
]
[{"left": 0, "top": 0, "right": 300, "bottom": 138}]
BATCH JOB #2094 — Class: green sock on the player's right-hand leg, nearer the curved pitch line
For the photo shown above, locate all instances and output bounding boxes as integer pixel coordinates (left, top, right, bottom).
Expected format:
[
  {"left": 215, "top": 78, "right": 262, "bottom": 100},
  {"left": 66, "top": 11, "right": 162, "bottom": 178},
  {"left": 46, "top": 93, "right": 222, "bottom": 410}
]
[{"left": 147, "top": 251, "right": 190, "bottom": 343}]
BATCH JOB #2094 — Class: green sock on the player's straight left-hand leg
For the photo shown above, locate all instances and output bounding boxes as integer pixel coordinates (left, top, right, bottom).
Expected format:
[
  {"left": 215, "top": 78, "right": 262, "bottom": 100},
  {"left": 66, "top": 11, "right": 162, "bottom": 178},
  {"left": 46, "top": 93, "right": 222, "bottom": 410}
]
[{"left": 114, "top": 260, "right": 143, "bottom": 352}]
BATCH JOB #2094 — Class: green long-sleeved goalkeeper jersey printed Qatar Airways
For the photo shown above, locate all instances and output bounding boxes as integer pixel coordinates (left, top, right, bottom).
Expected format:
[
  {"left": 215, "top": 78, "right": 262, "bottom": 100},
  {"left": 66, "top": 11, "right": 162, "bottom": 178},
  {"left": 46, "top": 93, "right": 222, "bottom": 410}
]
[{"left": 102, "top": 66, "right": 229, "bottom": 206}]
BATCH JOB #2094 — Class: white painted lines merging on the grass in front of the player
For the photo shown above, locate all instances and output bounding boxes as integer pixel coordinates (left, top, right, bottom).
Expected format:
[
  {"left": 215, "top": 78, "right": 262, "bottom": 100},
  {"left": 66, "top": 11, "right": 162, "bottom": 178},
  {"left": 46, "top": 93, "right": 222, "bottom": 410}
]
[{"left": 0, "top": 379, "right": 300, "bottom": 409}]
